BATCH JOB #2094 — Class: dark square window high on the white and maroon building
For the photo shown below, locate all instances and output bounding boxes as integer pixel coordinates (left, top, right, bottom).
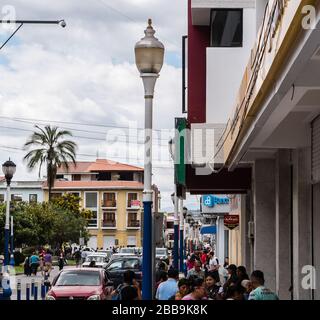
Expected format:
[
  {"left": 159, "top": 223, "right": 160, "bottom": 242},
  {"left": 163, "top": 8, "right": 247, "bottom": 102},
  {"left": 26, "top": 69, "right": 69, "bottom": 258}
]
[{"left": 210, "top": 9, "right": 243, "bottom": 47}]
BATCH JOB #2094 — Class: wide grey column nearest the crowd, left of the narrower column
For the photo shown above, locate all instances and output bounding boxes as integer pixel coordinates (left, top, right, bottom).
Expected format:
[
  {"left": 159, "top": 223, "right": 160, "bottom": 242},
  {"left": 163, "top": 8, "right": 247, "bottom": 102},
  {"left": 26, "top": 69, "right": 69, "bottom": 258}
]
[{"left": 253, "top": 159, "right": 276, "bottom": 291}]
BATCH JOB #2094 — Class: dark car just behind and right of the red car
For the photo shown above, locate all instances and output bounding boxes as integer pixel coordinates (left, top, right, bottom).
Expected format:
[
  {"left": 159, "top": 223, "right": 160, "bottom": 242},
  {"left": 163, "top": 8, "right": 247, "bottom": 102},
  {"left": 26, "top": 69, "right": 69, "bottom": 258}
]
[{"left": 106, "top": 256, "right": 142, "bottom": 288}]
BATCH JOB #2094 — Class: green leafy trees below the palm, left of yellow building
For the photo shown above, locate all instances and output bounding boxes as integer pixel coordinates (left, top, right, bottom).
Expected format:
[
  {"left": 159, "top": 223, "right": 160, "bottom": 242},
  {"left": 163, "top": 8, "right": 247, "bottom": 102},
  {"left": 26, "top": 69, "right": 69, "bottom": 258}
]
[{"left": 0, "top": 199, "right": 88, "bottom": 254}]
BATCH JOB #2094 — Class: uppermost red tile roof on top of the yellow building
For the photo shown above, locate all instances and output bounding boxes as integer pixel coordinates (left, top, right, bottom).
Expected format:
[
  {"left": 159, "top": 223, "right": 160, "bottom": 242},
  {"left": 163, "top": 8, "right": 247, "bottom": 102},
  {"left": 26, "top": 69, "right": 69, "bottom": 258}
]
[{"left": 57, "top": 159, "right": 143, "bottom": 174}]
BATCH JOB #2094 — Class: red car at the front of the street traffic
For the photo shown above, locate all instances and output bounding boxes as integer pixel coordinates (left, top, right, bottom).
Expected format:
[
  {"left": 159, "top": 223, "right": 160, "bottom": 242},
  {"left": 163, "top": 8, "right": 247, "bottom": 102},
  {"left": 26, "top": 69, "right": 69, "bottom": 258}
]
[{"left": 46, "top": 268, "right": 113, "bottom": 300}]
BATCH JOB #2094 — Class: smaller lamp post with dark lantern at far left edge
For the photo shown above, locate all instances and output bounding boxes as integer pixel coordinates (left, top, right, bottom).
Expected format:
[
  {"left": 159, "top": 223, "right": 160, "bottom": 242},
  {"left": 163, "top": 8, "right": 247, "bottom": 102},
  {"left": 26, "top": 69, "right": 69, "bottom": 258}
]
[{"left": 2, "top": 159, "right": 16, "bottom": 266}]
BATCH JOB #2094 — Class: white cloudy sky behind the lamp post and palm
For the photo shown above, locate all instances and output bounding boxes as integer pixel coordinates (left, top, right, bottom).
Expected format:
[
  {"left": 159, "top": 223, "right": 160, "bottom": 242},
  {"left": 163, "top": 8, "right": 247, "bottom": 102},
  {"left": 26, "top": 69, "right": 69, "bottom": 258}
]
[{"left": 0, "top": 0, "right": 197, "bottom": 208}]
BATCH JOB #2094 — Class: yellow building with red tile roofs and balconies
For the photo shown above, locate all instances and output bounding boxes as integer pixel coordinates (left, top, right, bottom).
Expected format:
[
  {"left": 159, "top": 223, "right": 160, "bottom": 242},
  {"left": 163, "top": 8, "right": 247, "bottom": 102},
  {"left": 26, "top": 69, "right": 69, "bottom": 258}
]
[{"left": 45, "top": 159, "right": 143, "bottom": 249}]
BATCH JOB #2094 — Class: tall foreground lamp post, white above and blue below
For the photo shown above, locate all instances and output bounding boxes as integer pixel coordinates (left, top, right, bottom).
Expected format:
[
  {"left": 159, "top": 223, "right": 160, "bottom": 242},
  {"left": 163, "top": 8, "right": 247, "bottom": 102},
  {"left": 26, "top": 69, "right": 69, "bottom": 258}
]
[{"left": 135, "top": 19, "right": 164, "bottom": 300}]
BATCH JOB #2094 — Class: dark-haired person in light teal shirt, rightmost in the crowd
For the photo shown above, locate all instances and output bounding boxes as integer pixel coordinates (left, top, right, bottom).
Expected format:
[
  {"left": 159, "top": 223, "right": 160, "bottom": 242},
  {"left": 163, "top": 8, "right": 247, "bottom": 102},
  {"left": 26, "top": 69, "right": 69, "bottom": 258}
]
[{"left": 249, "top": 270, "right": 279, "bottom": 300}]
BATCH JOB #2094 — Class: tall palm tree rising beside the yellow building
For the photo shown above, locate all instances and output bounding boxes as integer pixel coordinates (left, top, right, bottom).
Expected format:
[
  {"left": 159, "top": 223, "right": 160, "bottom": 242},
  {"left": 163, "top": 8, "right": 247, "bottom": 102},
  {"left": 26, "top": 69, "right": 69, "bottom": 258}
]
[{"left": 23, "top": 126, "right": 77, "bottom": 201}]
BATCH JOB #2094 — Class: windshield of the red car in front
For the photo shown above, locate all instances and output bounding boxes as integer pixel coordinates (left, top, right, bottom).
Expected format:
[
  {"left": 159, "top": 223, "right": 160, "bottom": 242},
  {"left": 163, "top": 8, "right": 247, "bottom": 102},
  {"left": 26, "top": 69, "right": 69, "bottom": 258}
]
[{"left": 55, "top": 271, "right": 101, "bottom": 286}]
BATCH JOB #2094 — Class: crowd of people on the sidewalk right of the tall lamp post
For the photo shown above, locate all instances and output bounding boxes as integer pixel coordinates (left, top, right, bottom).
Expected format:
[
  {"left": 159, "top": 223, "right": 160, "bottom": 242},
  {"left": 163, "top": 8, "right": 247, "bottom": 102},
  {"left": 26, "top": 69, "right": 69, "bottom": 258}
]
[{"left": 155, "top": 250, "right": 278, "bottom": 300}]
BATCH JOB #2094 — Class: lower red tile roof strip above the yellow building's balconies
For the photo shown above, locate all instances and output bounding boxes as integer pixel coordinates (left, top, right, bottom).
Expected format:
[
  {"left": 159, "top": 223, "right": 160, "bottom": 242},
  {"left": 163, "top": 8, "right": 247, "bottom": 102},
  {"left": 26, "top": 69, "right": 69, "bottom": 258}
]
[{"left": 44, "top": 181, "right": 143, "bottom": 190}]
